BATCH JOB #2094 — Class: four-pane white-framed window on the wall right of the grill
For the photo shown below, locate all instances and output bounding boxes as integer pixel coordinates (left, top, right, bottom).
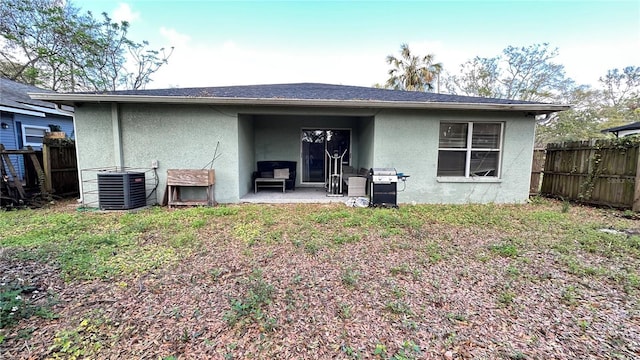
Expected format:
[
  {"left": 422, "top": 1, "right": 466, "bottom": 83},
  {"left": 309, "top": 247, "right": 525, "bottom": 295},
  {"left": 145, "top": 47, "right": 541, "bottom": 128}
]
[{"left": 438, "top": 122, "right": 503, "bottom": 177}]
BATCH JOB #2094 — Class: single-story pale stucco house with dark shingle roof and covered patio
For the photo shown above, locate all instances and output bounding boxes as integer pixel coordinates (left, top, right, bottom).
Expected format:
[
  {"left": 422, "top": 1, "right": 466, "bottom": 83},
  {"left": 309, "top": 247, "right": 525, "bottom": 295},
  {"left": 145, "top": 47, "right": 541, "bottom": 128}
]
[{"left": 31, "top": 83, "right": 569, "bottom": 203}]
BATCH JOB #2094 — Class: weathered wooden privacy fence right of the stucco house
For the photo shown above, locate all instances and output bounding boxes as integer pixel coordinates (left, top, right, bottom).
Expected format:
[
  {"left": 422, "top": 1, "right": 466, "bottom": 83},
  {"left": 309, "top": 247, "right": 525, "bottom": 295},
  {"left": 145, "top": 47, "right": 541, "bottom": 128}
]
[{"left": 532, "top": 138, "right": 640, "bottom": 211}]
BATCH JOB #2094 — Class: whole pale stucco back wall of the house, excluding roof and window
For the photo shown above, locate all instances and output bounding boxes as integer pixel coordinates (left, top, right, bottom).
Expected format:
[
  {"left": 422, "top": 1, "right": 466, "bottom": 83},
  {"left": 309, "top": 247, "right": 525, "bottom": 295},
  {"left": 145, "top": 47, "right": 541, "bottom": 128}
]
[{"left": 76, "top": 104, "right": 535, "bottom": 207}]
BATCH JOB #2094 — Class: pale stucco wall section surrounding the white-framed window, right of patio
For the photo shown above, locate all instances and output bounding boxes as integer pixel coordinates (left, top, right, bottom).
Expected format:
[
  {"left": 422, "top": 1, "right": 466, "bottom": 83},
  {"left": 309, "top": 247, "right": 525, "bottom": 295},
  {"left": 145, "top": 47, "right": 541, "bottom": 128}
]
[{"left": 374, "top": 111, "right": 535, "bottom": 204}]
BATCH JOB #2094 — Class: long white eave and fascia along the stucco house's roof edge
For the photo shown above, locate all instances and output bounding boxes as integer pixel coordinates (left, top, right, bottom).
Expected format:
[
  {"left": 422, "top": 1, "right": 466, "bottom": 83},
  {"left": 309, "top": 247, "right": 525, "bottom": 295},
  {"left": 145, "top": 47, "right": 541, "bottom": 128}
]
[{"left": 29, "top": 93, "right": 571, "bottom": 114}]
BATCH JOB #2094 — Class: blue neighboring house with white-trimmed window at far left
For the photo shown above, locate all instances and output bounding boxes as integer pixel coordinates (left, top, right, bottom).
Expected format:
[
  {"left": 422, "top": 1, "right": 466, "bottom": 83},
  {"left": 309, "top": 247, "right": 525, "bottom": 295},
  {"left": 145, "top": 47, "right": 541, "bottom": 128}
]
[{"left": 0, "top": 78, "right": 74, "bottom": 178}]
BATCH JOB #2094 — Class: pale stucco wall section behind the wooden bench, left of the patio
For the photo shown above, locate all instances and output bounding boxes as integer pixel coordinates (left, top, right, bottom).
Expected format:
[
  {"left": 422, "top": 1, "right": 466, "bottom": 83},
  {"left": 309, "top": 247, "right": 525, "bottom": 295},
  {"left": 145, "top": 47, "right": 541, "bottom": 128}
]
[{"left": 120, "top": 104, "right": 239, "bottom": 203}]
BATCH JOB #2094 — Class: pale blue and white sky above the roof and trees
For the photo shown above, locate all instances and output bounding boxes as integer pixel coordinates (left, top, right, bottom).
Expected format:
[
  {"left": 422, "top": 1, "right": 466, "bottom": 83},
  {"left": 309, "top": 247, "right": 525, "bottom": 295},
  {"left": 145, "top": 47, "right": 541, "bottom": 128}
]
[{"left": 73, "top": 0, "right": 640, "bottom": 88}]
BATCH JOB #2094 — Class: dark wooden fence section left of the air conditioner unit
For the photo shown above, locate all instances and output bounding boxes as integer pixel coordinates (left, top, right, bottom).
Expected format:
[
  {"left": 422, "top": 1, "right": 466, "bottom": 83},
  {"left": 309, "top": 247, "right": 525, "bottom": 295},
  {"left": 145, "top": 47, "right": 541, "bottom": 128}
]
[{"left": 42, "top": 139, "right": 80, "bottom": 196}]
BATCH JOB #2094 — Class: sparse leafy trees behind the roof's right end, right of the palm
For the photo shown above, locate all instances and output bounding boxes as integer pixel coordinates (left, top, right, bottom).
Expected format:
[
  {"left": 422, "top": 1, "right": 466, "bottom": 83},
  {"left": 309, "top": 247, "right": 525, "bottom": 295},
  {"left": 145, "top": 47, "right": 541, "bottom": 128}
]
[{"left": 445, "top": 43, "right": 640, "bottom": 146}]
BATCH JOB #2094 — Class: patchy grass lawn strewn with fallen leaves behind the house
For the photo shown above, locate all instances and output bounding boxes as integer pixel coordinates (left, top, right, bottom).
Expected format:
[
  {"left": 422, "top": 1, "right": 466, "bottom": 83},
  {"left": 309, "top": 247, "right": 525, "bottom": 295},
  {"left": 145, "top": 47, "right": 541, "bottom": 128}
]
[{"left": 0, "top": 199, "right": 640, "bottom": 359}]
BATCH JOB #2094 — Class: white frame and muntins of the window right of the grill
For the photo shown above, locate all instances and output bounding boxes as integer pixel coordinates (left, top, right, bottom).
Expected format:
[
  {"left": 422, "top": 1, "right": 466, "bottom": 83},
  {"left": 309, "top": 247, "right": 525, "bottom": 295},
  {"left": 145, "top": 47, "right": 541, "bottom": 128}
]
[{"left": 436, "top": 120, "right": 504, "bottom": 179}]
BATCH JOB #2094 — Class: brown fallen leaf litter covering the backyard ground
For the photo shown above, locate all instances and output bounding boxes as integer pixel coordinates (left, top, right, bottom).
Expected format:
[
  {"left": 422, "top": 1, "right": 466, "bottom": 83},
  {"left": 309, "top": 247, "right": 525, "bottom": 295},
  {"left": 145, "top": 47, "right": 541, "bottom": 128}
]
[{"left": 0, "top": 201, "right": 640, "bottom": 359}]
